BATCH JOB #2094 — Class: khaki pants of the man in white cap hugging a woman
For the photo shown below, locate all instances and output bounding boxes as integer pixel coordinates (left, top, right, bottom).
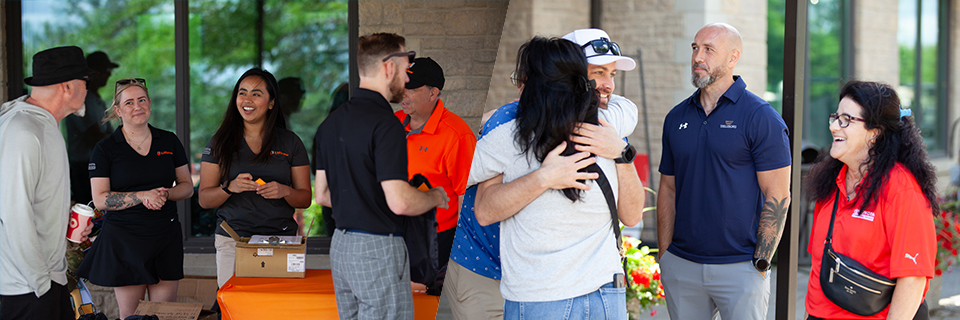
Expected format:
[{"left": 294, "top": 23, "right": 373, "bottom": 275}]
[{"left": 442, "top": 259, "right": 504, "bottom": 320}]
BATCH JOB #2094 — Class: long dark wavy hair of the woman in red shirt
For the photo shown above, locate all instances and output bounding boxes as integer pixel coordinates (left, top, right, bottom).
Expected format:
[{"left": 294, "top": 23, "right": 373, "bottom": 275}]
[{"left": 807, "top": 81, "right": 940, "bottom": 215}]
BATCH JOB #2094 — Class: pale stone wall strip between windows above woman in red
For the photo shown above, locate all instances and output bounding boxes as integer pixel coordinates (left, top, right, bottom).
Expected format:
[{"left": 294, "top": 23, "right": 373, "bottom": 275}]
[{"left": 853, "top": 0, "right": 900, "bottom": 86}]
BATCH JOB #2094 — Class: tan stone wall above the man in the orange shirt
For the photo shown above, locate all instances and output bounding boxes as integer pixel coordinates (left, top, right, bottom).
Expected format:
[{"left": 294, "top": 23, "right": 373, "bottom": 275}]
[{"left": 359, "top": 0, "right": 509, "bottom": 130}]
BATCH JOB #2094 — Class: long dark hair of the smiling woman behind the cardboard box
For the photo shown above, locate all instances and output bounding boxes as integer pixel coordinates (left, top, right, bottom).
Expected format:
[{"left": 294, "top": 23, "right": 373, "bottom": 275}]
[{"left": 212, "top": 68, "right": 287, "bottom": 181}]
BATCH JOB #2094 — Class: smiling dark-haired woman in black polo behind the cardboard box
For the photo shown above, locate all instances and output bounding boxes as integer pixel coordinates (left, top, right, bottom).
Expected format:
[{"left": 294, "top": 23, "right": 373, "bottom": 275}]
[{"left": 199, "top": 68, "right": 312, "bottom": 286}]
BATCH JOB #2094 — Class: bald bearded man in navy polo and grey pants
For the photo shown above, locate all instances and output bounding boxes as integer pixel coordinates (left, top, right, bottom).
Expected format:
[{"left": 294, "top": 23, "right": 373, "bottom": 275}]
[{"left": 657, "top": 23, "right": 791, "bottom": 320}]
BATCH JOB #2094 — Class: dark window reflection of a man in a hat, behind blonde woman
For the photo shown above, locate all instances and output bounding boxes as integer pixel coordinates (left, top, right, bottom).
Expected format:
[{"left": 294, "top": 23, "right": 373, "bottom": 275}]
[{"left": 63, "top": 51, "right": 120, "bottom": 203}]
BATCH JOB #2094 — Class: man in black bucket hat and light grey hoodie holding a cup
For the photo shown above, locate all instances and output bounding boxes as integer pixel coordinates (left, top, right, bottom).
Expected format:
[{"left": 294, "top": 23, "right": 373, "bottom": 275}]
[{"left": 0, "top": 46, "right": 93, "bottom": 320}]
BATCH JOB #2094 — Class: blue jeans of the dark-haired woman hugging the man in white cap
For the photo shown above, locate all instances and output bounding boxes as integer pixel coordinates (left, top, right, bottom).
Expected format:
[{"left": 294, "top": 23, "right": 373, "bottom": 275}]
[{"left": 503, "top": 282, "right": 627, "bottom": 320}]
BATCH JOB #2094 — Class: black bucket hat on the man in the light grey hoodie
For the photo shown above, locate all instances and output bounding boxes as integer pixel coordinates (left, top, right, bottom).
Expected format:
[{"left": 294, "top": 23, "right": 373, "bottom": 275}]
[{"left": 23, "top": 46, "right": 93, "bottom": 87}]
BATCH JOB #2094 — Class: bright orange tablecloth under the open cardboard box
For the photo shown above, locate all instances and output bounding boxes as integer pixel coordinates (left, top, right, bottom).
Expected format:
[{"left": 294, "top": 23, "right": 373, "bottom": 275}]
[{"left": 217, "top": 269, "right": 440, "bottom": 320}]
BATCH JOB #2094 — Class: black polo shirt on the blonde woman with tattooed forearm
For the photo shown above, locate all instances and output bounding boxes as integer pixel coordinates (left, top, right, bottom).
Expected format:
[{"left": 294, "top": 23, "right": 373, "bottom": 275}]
[{"left": 88, "top": 126, "right": 187, "bottom": 229}]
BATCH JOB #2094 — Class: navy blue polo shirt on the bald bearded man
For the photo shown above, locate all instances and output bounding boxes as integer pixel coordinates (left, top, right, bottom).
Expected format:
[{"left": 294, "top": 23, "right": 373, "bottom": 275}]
[{"left": 660, "top": 76, "right": 791, "bottom": 264}]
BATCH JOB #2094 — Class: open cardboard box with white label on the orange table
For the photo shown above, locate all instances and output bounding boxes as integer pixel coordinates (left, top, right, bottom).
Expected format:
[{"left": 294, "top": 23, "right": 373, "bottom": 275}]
[{"left": 220, "top": 221, "right": 307, "bottom": 278}]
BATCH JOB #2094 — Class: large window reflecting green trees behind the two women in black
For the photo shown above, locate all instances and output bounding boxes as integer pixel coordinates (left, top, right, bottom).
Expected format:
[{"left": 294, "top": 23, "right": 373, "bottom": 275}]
[{"left": 15, "top": 0, "right": 357, "bottom": 253}]
